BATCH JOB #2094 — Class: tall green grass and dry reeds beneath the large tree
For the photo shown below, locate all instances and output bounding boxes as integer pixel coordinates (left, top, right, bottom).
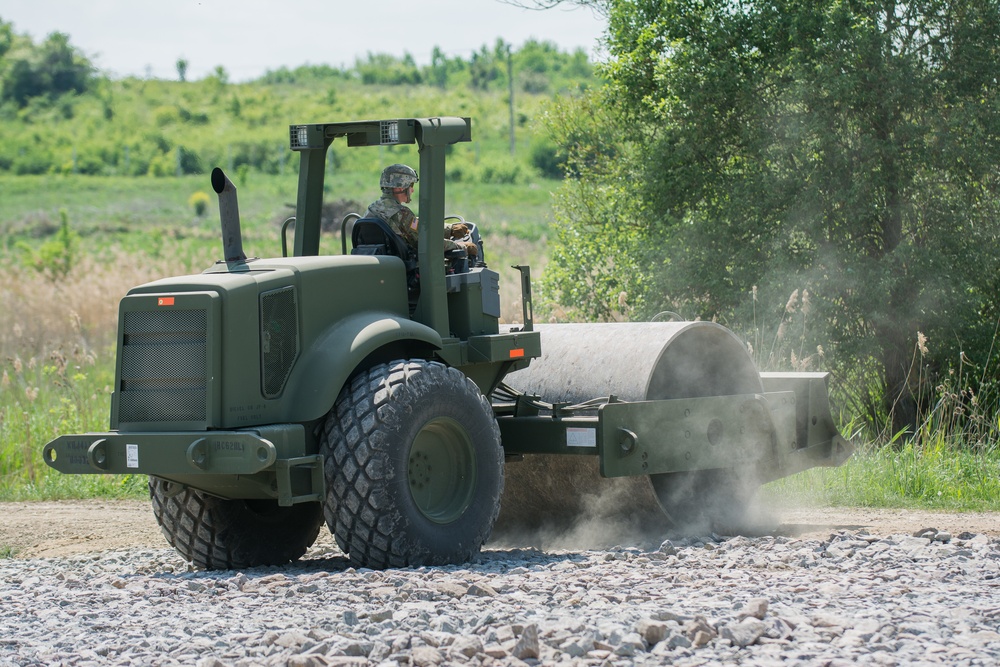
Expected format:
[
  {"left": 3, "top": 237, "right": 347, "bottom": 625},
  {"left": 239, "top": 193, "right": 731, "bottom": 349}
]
[{"left": 749, "top": 290, "right": 1000, "bottom": 510}]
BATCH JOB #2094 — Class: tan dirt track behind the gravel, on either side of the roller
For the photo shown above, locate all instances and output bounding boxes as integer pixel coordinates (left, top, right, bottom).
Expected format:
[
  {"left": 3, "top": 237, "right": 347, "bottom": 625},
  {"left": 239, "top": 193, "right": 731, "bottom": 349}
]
[{"left": 0, "top": 500, "right": 1000, "bottom": 558}]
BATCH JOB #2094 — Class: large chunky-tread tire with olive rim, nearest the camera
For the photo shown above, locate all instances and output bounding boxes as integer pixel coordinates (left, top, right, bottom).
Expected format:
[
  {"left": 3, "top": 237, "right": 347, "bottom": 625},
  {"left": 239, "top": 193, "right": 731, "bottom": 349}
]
[{"left": 320, "top": 360, "right": 504, "bottom": 569}]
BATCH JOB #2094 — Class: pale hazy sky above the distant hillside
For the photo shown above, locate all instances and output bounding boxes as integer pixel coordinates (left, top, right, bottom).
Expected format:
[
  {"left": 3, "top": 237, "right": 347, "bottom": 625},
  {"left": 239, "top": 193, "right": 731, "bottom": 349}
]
[{"left": 0, "top": 0, "right": 605, "bottom": 82}]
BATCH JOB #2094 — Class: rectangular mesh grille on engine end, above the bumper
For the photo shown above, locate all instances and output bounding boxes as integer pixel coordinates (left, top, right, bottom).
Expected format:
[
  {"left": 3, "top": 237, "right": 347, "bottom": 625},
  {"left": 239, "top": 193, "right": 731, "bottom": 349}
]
[{"left": 118, "top": 310, "right": 208, "bottom": 423}]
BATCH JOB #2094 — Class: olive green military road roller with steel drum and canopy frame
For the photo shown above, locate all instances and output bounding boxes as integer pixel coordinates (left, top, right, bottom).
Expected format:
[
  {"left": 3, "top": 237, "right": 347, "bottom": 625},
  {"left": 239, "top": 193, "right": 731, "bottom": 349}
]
[{"left": 43, "top": 117, "right": 853, "bottom": 569}]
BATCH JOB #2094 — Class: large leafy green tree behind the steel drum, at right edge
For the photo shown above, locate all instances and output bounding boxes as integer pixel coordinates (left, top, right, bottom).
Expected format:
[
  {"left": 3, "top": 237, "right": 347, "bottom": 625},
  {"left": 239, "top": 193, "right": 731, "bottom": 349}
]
[{"left": 552, "top": 0, "right": 1000, "bottom": 440}]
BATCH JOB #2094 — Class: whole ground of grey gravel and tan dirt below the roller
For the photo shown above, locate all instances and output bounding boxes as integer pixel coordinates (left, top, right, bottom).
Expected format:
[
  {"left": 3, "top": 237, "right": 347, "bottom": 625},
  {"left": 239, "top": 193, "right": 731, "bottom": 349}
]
[{"left": 0, "top": 501, "right": 1000, "bottom": 667}]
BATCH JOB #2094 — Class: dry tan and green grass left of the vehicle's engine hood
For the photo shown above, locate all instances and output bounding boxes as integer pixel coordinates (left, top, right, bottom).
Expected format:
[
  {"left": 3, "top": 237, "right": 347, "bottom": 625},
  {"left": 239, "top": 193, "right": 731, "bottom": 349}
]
[{"left": 0, "top": 237, "right": 219, "bottom": 499}]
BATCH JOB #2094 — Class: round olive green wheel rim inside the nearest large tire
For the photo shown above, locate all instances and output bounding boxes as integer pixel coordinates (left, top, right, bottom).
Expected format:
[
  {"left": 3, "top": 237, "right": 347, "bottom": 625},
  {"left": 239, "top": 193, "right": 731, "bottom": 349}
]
[{"left": 407, "top": 417, "right": 476, "bottom": 524}]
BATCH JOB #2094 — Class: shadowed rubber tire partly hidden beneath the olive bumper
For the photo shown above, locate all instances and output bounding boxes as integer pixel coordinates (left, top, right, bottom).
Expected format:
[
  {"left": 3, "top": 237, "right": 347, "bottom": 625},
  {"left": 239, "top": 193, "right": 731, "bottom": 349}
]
[{"left": 149, "top": 477, "right": 323, "bottom": 570}]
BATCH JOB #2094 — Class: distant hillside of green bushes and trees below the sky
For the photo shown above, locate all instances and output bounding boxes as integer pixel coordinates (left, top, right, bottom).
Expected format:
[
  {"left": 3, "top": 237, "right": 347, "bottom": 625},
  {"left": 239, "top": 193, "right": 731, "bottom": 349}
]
[{"left": 0, "top": 18, "right": 598, "bottom": 183}]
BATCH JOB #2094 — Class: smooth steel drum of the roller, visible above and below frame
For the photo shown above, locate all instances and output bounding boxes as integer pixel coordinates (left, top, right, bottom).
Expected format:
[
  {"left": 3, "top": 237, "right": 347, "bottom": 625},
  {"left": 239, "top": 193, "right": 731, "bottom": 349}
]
[{"left": 497, "top": 322, "right": 763, "bottom": 534}]
